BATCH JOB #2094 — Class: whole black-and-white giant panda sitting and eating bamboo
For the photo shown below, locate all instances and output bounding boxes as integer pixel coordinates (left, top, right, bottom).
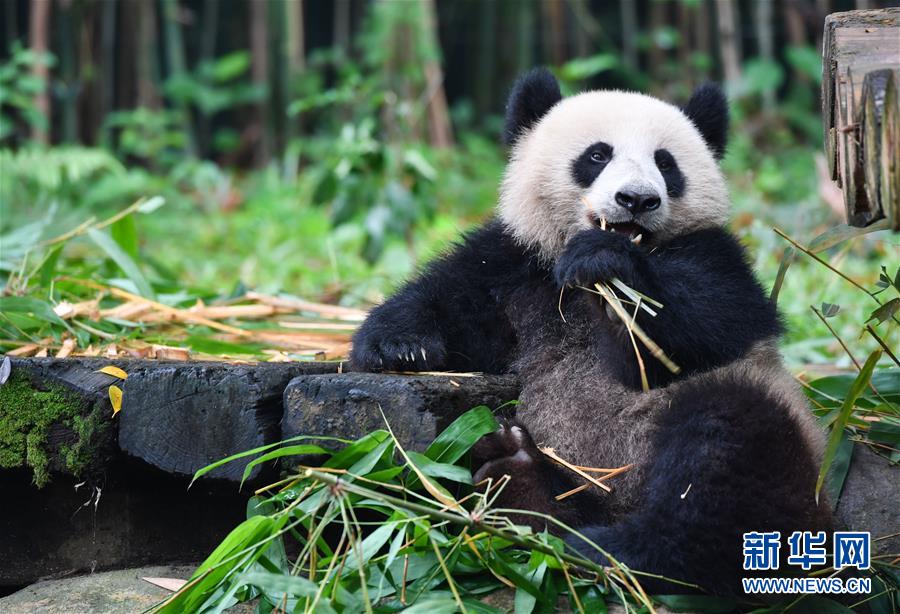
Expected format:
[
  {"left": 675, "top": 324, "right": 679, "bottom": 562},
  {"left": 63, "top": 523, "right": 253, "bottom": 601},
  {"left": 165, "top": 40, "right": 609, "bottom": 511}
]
[{"left": 352, "top": 69, "right": 831, "bottom": 593}]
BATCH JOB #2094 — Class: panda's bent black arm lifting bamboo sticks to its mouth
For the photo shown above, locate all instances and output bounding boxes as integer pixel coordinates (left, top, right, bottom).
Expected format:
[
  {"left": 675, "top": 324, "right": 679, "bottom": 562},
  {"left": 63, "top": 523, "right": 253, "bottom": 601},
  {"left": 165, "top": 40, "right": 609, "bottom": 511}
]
[{"left": 555, "top": 229, "right": 781, "bottom": 373}]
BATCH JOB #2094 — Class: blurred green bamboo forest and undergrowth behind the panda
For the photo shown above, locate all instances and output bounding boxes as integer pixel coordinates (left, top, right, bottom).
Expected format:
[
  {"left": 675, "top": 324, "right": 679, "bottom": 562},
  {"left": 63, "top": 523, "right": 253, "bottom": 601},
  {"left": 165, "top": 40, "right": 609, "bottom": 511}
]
[{"left": 0, "top": 0, "right": 896, "bottom": 366}]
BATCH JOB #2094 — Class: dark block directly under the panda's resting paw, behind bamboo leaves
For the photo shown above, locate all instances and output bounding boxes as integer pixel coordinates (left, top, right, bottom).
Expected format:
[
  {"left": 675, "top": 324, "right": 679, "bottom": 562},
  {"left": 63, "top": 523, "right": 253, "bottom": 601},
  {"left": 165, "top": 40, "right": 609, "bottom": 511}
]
[{"left": 282, "top": 373, "right": 519, "bottom": 452}]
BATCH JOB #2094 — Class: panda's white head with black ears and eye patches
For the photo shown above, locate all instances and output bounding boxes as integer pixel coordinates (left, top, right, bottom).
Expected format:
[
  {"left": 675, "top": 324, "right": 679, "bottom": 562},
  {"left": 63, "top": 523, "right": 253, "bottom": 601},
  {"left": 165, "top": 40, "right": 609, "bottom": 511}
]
[{"left": 499, "top": 69, "right": 729, "bottom": 261}]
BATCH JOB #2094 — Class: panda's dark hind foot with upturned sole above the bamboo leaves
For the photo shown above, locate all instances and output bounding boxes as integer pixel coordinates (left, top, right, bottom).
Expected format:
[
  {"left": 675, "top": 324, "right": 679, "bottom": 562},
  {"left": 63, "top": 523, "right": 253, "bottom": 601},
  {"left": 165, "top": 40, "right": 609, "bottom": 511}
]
[{"left": 472, "top": 420, "right": 599, "bottom": 533}]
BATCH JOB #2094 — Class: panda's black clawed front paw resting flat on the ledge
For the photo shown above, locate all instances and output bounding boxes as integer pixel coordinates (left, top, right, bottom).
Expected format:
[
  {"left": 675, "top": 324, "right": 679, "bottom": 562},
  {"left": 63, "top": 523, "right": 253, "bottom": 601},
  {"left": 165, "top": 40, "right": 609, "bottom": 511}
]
[{"left": 350, "top": 330, "right": 447, "bottom": 371}]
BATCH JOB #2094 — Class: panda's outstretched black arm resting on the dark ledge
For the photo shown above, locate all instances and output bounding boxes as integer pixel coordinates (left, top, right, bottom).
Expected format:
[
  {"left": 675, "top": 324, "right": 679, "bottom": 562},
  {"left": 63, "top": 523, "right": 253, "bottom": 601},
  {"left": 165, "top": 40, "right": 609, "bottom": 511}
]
[{"left": 351, "top": 222, "right": 527, "bottom": 373}]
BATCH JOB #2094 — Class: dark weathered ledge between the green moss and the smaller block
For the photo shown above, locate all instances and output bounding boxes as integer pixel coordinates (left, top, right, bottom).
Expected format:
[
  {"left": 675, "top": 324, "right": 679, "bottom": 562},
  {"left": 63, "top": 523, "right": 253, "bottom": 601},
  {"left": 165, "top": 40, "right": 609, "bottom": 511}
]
[{"left": 0, "top": 358, "right": 340, "bottom": 480}]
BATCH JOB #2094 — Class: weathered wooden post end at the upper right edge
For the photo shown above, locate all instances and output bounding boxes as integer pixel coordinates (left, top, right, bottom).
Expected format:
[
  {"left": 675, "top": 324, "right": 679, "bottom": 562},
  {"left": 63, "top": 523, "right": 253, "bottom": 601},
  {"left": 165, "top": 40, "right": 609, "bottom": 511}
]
[{"left": 822, "top": 8, "right": 900, "bottom": 230}]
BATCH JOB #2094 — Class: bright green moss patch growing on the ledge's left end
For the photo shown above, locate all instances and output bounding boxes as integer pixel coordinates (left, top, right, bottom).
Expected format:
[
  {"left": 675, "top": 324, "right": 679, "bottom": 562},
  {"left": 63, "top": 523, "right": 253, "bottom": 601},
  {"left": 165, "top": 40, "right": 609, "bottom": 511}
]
[{"left": 0, "top": 371, "right": 100, "bottom": 487}]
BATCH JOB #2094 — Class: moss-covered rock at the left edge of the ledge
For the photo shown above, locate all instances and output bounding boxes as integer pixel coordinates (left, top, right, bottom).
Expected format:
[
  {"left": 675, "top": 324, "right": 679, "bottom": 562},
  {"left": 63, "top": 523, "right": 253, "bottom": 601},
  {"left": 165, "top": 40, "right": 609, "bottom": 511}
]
[{"left": 0, "top": 369, "right": 112, "bottom": 487}]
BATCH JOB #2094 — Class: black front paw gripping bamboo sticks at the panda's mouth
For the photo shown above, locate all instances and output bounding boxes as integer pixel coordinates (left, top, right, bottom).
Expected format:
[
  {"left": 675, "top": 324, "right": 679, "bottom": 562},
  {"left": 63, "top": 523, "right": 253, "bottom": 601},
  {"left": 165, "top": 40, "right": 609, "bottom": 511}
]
[{"left": 553, "top": 229, "right": 644, "bottom": 288}]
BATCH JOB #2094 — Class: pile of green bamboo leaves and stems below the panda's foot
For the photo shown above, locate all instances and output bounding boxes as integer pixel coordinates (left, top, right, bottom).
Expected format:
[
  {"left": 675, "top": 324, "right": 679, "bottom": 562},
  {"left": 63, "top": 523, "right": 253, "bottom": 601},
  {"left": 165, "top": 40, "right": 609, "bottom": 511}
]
[{"left": 156, "top": 407, "right": 668, "bottom": 613}]
